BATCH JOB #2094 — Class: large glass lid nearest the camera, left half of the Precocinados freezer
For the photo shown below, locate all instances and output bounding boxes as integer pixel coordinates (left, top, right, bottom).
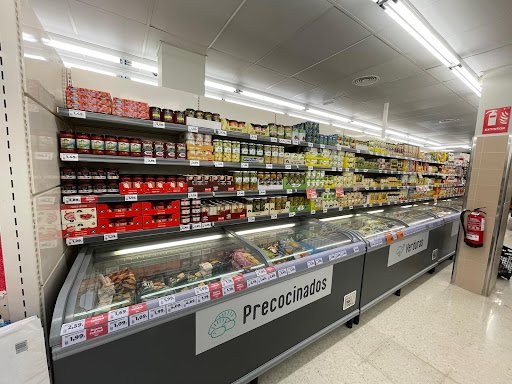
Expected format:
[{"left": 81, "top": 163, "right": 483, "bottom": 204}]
[{"left": 66, "top": 231, "right": 267, "bottom": 322}]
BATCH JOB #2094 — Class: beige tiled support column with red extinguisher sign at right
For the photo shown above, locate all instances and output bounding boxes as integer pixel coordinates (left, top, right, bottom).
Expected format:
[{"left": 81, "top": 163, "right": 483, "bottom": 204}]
[{"left": 452, "top": 66, "right": 512, "bottom": 296}]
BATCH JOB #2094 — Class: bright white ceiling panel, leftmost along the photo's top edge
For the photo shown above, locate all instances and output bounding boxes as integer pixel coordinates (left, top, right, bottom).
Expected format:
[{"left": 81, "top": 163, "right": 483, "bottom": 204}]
[{"left": 29, "top": 0, "right": 77, "bottom": 38}]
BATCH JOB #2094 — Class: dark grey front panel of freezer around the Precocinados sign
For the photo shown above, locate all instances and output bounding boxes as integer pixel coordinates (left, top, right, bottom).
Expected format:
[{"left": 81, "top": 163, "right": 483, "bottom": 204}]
[{"left": 53, "top": 255, "right": 364, "bottom": 384}]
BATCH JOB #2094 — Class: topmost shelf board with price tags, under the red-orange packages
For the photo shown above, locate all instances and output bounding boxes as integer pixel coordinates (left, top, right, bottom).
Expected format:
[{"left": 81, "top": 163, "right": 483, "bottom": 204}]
[{"left": 57, "top": 108, "right": 468, "bottom": 169}]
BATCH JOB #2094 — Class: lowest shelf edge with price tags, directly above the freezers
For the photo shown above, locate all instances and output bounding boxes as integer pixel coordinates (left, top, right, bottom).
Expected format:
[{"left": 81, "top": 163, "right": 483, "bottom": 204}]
[{"left": 66, "top": 195, "right": 462, "bottom": 245}]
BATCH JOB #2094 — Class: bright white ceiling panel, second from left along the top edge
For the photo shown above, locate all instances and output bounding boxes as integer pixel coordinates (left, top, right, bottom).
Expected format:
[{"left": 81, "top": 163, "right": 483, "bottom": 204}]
[{"left": 69, "top": 0, "right": 146, "bottom": 56}]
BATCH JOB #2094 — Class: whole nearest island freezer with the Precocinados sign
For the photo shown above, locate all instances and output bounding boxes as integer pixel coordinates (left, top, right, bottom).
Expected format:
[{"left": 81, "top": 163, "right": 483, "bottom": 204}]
[{"left": 50, "top": 217, "right": 366, "bottom": 384}]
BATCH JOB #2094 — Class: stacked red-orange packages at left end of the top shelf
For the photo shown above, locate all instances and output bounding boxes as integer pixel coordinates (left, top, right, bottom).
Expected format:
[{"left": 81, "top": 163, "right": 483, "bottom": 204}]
[{"left": 66, "top": 85, "right": 112, "bottom": 113}]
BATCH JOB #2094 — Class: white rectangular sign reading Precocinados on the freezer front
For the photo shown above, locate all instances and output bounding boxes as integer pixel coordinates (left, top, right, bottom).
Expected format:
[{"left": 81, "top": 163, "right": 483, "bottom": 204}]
[{"left": 196, "top": 265, "right": 332, "bottom": 355}]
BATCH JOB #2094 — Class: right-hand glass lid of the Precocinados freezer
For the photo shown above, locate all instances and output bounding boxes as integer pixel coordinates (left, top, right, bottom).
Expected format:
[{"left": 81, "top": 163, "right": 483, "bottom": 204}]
[{"left": 236, "top": 220, "right": 352, "bottom": 265}]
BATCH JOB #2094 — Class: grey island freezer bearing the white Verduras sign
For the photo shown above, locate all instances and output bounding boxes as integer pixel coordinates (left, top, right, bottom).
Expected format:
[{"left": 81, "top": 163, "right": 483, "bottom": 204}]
[{"left": 323, "top": 208, "right": 442, "bottom": 313}]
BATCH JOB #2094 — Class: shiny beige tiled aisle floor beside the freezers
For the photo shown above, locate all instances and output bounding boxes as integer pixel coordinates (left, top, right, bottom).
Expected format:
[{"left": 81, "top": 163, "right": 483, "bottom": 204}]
[{"left": 260, "top": 261, "right": 512, "bottom": 384}]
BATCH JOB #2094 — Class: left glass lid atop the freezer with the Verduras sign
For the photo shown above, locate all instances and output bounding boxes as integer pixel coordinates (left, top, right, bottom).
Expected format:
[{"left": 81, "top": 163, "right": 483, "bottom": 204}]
[{"left": 321, "top": 210, "right": 405, "bottom": 239}]
